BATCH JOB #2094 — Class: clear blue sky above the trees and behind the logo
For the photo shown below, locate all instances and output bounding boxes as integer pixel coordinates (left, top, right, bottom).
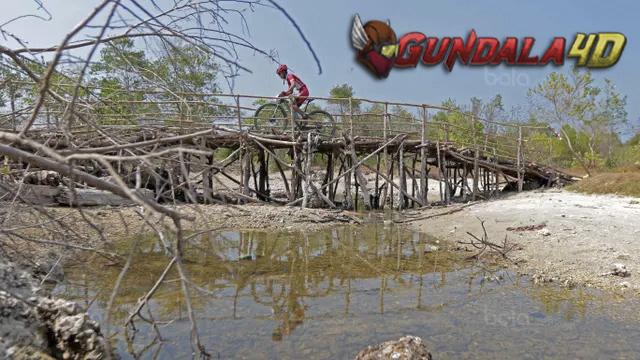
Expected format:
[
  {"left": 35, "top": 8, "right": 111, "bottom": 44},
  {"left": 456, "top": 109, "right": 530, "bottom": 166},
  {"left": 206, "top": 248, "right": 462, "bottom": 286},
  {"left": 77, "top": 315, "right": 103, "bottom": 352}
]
[{"left": 5, "top": 0, "right": 640, "bottom": 137}]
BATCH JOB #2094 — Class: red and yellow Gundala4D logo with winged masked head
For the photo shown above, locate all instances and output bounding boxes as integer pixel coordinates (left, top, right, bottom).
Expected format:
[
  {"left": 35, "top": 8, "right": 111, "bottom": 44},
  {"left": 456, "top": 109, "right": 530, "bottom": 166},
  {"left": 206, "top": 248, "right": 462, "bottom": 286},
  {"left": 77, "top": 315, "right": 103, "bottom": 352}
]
[{"left": 351, "top": 14, "right": 627, "bottom": 79}]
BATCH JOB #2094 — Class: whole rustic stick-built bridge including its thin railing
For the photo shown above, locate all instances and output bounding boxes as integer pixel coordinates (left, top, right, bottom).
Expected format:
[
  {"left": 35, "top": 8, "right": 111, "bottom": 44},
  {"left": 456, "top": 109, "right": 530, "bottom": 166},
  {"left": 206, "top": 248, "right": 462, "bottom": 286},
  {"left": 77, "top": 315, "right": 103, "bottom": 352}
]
[{"left": 0, "top": 83, "right": 573, "bottom": 208}]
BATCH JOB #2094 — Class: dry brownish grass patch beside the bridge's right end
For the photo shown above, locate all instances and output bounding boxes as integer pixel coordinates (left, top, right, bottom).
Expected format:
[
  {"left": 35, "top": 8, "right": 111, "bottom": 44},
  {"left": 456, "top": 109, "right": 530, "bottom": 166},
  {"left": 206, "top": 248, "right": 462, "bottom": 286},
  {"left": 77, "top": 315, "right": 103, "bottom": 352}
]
[{"left": 567, "top": 168, "right": 640, "bottom": 198}]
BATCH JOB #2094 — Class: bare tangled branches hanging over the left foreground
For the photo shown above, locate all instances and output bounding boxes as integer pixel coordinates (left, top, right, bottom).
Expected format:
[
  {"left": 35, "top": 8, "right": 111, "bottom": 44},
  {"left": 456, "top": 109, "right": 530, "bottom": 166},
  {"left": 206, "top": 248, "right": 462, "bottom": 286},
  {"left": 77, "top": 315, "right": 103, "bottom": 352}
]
[{"left": 0, "top": 0, "right": 321, "bottom": 356}]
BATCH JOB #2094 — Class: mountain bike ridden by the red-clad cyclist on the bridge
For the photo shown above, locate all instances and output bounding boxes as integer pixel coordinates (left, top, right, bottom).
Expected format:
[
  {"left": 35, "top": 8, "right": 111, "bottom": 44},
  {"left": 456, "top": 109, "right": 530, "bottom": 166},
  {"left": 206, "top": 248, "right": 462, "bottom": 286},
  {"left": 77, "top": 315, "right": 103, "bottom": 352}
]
[{"left": 254, "top": 97, "right": 337, "bottom": 137}]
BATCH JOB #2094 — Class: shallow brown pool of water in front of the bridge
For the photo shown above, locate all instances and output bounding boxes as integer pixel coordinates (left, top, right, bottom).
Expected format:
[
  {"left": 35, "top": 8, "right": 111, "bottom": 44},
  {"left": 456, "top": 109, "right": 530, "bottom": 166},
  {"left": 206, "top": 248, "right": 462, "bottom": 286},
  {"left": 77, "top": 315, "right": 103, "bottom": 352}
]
[{"left": 54, "top": 224, "right": 640, "bottom": 359}]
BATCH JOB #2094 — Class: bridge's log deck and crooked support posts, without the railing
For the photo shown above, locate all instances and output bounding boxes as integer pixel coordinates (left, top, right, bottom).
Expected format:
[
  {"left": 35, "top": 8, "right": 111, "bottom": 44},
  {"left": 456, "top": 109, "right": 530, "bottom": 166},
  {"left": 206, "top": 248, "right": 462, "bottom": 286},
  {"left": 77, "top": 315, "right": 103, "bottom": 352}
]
[{"left": 1, "top": 126, "right": 575, "bottom": 209}]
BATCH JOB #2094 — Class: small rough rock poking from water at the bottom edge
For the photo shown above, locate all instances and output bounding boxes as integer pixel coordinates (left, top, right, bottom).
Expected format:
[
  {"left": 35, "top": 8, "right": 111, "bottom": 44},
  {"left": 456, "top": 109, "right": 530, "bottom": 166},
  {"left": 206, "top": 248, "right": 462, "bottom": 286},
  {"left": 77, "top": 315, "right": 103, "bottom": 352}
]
[{"left": 355, "top": 335, "right": 432, "bottom": 360}]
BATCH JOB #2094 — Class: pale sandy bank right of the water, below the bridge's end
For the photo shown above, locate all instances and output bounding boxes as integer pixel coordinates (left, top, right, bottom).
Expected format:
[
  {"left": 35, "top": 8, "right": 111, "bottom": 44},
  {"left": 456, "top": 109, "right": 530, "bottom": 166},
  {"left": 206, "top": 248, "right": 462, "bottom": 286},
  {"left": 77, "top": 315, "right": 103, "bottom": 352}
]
[{"left": 407, "top": 189, "right": 640, "bottom": 296}]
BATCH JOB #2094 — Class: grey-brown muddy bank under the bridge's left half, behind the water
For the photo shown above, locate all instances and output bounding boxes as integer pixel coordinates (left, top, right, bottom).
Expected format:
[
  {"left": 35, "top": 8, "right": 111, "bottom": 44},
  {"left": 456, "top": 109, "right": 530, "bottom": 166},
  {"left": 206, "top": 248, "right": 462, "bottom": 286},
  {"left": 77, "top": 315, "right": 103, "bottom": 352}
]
[{"left": 0, "top": 203, "right": 367, "bottom": 263}]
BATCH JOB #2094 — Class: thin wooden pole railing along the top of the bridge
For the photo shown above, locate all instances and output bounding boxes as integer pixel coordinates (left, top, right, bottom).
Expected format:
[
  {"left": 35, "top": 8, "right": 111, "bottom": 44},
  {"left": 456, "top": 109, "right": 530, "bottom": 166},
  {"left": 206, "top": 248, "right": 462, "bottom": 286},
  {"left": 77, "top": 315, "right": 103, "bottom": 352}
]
[{"left": 0, "top": 82, "right": 553, "bottom": 177}]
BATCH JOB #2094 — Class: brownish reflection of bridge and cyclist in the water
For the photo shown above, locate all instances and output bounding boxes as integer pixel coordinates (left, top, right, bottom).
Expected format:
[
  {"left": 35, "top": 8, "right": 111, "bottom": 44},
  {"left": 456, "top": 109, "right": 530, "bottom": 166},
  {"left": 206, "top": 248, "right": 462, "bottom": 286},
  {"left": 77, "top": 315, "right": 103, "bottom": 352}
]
[{"left": 57, "top": 224, "right": 585, "bottom": 356}]
